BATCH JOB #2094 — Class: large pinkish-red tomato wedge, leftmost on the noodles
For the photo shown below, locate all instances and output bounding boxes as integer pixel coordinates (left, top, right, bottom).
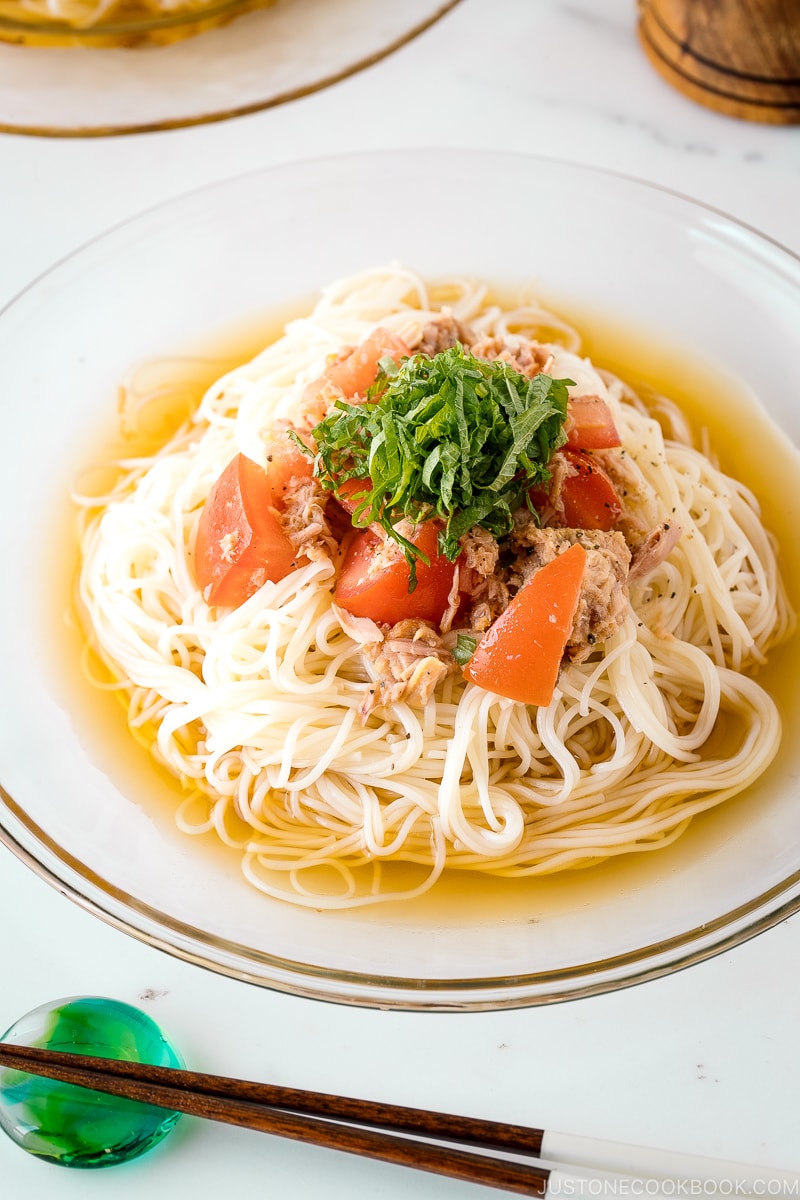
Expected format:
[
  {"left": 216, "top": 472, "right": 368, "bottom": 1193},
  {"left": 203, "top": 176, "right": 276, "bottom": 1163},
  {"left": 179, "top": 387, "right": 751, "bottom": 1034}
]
[{"left": 194, "top": 451, "right": 302, "bottom": 608}]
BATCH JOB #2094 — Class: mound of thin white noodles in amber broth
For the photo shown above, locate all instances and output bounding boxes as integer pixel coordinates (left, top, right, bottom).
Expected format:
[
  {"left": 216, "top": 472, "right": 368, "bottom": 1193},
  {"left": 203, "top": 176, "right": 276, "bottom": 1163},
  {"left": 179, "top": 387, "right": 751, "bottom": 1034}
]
[{"left": 73, "top": 266, "right": 793, "bottom": 907}]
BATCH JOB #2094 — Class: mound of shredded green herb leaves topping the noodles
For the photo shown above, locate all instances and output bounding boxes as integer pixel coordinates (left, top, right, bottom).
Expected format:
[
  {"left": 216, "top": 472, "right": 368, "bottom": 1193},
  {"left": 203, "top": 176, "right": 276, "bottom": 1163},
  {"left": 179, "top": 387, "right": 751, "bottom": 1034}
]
[{"left": 298, "top": 346, "right": 572, "bottom": 580}]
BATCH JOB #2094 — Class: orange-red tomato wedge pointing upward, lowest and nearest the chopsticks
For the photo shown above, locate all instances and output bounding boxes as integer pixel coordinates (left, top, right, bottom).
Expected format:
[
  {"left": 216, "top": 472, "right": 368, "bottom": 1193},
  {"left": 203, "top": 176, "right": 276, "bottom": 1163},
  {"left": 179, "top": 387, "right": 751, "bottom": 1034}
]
[{"left": 463, "top": 542, "right": 587, "bottom": 708}]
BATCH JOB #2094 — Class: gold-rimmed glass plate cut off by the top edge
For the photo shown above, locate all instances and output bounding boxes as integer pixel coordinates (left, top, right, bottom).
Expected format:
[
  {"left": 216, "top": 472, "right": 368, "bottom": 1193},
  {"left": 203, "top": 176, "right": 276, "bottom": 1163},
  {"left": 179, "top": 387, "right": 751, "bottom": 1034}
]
[{"left": 0, "top": 0, "right": 458, "bottom": 137}]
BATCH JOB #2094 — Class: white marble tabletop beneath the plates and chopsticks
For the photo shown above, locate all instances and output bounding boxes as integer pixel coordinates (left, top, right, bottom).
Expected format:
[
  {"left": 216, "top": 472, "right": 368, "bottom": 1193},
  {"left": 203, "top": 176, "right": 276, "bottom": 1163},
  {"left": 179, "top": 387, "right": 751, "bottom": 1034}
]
[{"left": 0, "top": 0, "right": 800, "bottom": 1200}]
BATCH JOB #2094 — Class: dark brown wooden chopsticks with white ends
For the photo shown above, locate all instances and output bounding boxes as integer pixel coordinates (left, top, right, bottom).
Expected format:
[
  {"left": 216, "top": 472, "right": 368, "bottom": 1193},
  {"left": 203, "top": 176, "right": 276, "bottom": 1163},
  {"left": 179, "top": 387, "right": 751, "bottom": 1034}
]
[{"left": 0, "top": 1043, "right": 800, "bottom": 1198}]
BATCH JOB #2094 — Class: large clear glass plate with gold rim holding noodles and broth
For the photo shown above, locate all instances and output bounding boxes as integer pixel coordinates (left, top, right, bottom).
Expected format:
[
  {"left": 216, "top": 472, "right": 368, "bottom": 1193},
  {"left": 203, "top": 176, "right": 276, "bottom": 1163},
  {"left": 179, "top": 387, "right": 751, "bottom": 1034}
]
[{"left": 0, "top": 150, "right": 800, "bottom": 1009}]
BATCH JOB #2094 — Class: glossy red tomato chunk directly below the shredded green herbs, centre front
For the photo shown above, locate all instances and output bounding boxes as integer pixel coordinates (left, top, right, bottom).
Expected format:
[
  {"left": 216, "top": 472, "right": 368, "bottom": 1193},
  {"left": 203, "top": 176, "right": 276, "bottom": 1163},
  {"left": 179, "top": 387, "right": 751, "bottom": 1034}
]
[{"left": 333, "top": 521, "right": 456, "bottom": 625}]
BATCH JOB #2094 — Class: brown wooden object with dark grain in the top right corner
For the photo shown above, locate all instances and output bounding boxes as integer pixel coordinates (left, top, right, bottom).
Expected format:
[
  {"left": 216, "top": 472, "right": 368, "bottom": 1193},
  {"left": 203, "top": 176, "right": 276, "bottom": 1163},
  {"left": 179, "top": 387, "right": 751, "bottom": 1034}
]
[{"left": 638, "top": 0, "right": 800, "bottom": 125}]
